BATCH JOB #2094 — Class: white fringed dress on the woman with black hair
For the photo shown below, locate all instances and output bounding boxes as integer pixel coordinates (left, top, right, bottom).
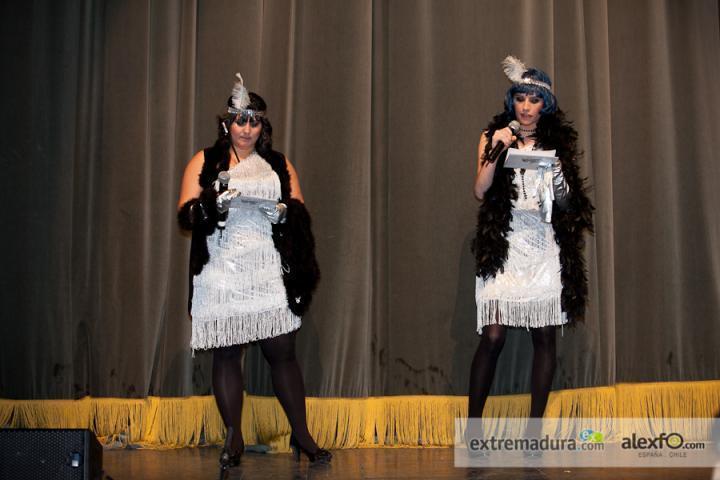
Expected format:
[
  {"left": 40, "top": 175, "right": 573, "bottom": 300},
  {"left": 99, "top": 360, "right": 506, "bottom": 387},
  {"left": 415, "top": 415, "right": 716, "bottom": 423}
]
[{"left": 191, "top": 153, "right": 301, "bottom": 350}]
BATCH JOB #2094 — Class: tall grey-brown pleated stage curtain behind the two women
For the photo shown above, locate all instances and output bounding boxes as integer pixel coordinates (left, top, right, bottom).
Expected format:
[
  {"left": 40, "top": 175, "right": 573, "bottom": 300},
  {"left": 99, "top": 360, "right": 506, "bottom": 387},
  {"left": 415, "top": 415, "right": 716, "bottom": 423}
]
[{"left": 0, "top": 0, "right": 720, "bottom": 399}]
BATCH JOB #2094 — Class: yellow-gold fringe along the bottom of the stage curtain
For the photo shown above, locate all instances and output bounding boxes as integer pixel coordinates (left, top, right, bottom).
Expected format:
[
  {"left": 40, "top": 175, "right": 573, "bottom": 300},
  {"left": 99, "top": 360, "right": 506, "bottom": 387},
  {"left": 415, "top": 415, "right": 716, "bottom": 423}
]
[{"left": 0, "top": 381, "right": 720, "bottom": 451}]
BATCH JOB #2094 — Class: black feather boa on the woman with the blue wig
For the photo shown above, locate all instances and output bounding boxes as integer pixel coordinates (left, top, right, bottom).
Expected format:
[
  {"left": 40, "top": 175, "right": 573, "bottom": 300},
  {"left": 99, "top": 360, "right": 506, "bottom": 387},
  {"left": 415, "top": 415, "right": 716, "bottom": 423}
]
[{"left": 473, "top": 110, "right": 594, "bottom": 321}]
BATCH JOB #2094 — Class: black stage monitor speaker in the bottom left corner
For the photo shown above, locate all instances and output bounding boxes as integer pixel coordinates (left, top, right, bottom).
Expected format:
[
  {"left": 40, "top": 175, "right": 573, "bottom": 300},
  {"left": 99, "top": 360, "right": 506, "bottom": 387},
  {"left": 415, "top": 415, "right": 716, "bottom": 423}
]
[{"left": 0, "top": 428, "right": 102, "bottom": 480}]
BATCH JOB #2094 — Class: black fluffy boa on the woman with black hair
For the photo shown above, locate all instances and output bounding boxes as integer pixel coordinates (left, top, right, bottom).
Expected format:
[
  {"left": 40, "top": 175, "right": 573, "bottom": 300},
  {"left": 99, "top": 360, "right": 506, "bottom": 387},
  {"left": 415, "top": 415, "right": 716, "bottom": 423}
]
[{"left": 180, "top": 142, "right": 320, "bottom": 316}]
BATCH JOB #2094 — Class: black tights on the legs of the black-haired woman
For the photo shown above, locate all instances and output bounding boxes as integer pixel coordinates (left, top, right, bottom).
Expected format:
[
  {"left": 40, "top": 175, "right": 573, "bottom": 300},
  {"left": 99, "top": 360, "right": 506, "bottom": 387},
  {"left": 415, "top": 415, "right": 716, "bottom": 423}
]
[{"left": 213, "top": 331, "right": 318, "bottom": 453}]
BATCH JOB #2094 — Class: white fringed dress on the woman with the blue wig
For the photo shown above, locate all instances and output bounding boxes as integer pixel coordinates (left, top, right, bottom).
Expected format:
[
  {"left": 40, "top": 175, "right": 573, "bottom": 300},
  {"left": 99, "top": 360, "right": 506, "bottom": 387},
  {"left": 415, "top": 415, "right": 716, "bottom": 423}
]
[{"left": 475, "top": 158, "right": 567, "bottom": 333}]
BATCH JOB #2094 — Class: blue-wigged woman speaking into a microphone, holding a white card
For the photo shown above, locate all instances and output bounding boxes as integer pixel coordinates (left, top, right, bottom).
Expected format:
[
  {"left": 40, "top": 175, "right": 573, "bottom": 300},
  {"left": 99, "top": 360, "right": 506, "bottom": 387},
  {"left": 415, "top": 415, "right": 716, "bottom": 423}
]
[{"left": 468, "top": 56, "right": 593, "bottom": 424}]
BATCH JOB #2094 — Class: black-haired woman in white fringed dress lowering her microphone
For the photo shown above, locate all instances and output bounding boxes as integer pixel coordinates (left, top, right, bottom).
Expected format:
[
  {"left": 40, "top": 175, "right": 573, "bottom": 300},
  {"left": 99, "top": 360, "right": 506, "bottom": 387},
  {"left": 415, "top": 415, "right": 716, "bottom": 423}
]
[{"left": 178, "top": 74, "right": 332, "bottom": 471}]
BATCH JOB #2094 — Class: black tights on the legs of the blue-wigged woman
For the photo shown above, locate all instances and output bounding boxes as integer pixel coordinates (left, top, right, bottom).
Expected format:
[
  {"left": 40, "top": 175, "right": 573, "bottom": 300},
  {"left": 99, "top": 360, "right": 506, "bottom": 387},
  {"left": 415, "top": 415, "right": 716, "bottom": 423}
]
[{"left": 468, "top": 324, "right": 556, "bottom": 418}]
